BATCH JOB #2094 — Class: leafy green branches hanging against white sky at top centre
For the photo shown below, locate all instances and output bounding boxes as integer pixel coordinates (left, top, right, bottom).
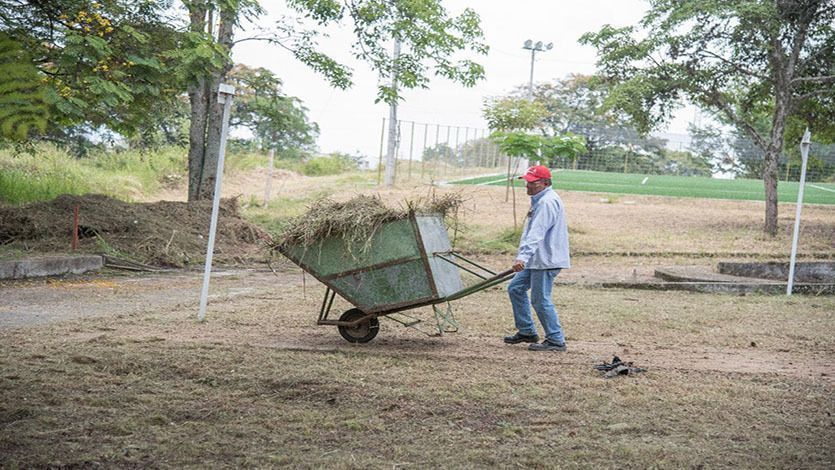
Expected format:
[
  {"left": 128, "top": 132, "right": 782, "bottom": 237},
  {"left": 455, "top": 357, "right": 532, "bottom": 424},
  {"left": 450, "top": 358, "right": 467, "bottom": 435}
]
[{"left": 284, "top": 0, "right": 487, "bottom": 103}]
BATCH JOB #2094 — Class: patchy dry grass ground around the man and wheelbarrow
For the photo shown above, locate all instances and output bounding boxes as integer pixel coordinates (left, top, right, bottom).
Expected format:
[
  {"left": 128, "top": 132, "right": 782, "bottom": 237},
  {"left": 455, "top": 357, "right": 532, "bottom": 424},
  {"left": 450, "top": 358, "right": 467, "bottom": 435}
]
[{"left": 0, "top": 169, "right": 835, "bottom": 468}]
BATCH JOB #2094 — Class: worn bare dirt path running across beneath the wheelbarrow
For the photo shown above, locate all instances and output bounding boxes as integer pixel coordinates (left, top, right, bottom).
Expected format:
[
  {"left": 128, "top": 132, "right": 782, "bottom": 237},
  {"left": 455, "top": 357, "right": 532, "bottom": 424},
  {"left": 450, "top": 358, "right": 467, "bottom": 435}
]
[{"left": 0, "top": 267, "right": 835, "bottom": 383}]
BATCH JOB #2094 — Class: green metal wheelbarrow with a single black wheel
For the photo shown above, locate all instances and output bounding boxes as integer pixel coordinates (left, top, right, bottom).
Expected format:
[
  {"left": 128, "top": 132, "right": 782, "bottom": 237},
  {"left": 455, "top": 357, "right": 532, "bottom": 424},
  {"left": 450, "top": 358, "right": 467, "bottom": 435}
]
[{"left": 278, "top": 213, "right": 514, "bottom": 343}]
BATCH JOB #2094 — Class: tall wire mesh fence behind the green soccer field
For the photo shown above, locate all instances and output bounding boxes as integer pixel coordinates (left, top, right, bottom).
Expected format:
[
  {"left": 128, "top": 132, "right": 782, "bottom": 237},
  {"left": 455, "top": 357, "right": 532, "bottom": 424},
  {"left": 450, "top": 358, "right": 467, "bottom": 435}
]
[{"left": 377, "top": 119, "right": 835, "bottom": 182}]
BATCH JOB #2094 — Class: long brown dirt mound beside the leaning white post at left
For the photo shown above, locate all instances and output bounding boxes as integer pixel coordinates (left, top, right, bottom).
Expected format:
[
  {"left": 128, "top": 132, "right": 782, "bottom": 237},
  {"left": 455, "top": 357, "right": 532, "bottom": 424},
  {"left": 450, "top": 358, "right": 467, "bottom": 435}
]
[{"left": 0, "top": 195, "right": 271, "bottom": 267}]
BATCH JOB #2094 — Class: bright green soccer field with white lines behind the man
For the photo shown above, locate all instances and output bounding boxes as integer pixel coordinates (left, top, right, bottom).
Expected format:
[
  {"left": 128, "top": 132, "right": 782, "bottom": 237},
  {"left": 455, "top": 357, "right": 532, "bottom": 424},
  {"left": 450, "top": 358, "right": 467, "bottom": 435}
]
[{"left": 453, "top": 170, "right": 835, "bottom": 204}]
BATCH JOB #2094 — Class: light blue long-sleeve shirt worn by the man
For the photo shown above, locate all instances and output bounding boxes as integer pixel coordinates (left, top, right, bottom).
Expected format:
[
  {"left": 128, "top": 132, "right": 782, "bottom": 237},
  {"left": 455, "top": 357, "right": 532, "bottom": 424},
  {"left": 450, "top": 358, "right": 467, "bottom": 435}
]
[{"left": 516, "top": 187, "right": 571, "bottom": 269}]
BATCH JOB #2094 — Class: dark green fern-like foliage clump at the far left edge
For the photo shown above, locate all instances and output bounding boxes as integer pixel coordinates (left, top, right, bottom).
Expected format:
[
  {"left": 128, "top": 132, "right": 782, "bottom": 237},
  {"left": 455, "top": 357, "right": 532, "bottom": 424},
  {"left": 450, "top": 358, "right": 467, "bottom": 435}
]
[{"left": 0, "top": 31, "right": 48, "bottom": 140}]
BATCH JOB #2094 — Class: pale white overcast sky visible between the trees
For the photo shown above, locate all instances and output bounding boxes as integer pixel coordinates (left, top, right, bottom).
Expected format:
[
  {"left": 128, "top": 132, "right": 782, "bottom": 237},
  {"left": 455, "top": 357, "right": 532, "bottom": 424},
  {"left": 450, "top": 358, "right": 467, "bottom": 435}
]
[{"left": 233, "top": 0, "right": 692, "bottom": 160}]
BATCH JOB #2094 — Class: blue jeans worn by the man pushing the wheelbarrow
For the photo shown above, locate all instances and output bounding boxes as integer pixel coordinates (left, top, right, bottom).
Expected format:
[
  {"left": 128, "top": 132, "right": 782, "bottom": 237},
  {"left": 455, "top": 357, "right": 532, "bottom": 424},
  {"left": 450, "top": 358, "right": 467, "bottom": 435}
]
[{"left": 507, "top": 269, "right": 565, "bottom": 344}]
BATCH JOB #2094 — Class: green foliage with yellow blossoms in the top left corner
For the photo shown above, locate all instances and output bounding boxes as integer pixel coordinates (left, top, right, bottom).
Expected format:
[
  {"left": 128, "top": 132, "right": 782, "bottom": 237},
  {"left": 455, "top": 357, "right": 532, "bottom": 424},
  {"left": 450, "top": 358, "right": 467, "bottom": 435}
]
[{"left": 0, "top": 0, "right": 185, "bottom": 140}]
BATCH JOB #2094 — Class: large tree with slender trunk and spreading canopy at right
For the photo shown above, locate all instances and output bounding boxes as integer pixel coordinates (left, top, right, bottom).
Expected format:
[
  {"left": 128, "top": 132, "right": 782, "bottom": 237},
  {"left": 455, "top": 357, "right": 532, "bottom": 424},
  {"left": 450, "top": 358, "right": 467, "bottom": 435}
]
[{"left": 581, "top": 0, "right": 835, "bottom": 235}]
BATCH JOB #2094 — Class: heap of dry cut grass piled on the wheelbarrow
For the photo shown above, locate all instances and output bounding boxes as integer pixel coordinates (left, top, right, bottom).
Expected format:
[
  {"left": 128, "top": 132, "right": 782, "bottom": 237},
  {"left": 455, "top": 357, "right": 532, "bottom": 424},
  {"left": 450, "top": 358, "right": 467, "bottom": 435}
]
[{"left": 278, "top": 193, "right": 464, "bottom": 252}]
